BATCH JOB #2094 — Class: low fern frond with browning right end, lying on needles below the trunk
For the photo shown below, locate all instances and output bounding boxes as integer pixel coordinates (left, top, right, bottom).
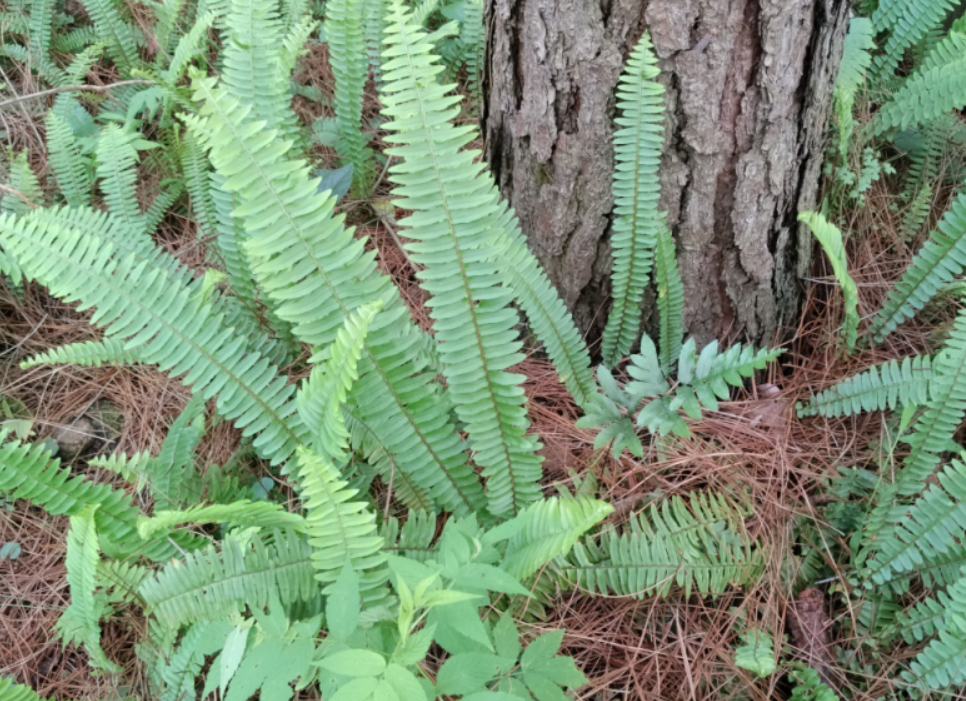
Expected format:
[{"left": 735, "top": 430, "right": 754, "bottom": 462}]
[{"left": 560, "top": 494, "right": 764, "bottom": 598}]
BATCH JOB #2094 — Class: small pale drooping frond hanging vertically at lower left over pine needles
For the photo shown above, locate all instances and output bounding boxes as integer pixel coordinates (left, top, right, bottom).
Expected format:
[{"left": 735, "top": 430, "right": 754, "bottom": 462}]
[{"left": 55, "top": 506, "right": 121, "bottom": 674}]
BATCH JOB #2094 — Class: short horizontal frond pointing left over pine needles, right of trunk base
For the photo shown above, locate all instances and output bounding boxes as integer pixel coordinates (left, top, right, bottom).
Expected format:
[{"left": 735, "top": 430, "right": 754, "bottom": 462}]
[{"left": 798, "top": 355, "right": 935, "bottom": 418}]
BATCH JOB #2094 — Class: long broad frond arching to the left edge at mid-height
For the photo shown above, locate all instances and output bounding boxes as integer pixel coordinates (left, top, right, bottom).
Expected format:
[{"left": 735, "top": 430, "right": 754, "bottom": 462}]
[{"left": 0, "top": 216, "right": 305, "bottom": 464}]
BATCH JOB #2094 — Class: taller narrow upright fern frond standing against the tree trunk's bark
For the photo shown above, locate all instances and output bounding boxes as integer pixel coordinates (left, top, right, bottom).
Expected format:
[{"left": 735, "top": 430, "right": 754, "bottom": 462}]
[{"left": 603, "top": 33, "right": 665, "bottom": 367}]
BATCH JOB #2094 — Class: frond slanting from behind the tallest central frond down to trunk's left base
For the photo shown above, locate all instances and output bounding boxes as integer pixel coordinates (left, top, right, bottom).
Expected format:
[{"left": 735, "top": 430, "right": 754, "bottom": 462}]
[{"left": 491, "top": 202, "right": 597, "bottom": 407}]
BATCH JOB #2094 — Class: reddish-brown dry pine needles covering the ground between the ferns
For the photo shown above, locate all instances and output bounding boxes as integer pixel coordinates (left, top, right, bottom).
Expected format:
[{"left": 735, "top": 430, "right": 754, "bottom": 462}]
[{"left": 0, "top": 41, "right": 964, "bottom": 701}]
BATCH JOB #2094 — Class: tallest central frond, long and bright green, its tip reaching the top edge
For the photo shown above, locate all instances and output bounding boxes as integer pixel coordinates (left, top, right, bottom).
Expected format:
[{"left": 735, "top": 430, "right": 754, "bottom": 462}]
[{"left": 383, "top": 0, "right": 540, "bottom": 515}]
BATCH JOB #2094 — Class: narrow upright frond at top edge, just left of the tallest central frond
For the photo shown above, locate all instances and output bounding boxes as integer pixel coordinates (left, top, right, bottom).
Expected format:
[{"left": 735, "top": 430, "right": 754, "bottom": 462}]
[{"left": 325, "top": 0, "right": 372, "bottom": 198}]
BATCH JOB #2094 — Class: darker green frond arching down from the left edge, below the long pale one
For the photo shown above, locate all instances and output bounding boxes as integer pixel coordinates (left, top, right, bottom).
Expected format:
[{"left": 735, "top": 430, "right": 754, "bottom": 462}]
[{"left": 0, "top": 434, "right": 197, "bottom": 560}]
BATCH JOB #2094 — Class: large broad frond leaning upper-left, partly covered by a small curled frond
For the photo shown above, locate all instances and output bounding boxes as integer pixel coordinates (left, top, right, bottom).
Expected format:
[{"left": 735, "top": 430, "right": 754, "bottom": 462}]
[{"left": 196, "top": 75, "right": 483, "bottom": 513}]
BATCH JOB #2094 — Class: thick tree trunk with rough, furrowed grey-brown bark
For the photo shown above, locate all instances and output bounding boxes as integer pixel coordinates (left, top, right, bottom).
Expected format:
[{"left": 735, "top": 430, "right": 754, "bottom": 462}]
[{"left": 484, "top": 0, "right": 849, "bottom": 343}]
